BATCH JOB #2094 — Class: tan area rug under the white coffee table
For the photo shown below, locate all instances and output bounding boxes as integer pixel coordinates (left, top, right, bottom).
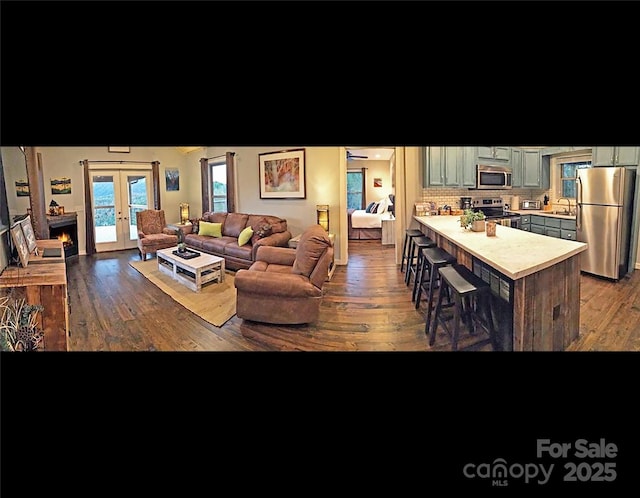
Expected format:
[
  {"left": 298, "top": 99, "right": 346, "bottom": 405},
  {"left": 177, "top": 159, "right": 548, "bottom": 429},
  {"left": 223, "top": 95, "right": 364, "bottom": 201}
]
[{"left": 129, "top": 258, "right": 236, "bottom": 327}]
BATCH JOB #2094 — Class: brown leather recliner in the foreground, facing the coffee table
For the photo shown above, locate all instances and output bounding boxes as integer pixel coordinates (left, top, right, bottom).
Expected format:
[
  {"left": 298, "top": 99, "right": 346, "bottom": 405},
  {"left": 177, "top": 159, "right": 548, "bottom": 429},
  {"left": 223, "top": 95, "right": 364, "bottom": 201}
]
[{"left": 234, "top": 225, "right": 333, "bottom": 324}]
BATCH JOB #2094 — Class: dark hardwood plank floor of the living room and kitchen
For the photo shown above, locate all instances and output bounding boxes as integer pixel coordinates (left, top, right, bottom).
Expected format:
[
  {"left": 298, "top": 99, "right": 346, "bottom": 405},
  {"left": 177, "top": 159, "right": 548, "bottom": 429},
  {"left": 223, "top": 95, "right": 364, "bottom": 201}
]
[{"left": 67, "top": 241, "right": 640, "bottom": 351}]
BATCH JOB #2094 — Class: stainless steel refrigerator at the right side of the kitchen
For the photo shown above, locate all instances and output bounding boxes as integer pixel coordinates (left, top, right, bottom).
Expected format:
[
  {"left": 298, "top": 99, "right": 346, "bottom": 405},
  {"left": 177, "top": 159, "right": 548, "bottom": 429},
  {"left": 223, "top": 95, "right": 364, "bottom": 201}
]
[{"left": 576, "top": 167, "right": 635, "bottom": 280}]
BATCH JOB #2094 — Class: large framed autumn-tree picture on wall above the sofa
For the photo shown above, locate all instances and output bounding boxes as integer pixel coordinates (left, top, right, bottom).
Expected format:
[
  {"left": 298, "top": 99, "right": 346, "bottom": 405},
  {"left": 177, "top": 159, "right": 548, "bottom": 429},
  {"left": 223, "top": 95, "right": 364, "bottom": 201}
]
[{"left": 258, "top": 149, "right": 307, "bottom": 199}]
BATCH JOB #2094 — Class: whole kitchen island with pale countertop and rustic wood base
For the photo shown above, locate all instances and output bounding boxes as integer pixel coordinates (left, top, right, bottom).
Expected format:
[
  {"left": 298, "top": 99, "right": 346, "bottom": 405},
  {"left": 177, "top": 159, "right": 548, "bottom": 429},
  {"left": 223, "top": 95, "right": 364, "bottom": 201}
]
[{"left": 414, "top": 216, "right": 587, "bottom": 351}]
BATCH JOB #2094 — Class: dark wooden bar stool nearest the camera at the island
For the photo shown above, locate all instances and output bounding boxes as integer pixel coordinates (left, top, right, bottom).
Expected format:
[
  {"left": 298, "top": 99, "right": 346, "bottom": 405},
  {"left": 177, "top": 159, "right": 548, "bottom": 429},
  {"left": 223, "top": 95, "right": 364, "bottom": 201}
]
[{"left": 425, "top": 264, "right": 499, "bottom": 351}]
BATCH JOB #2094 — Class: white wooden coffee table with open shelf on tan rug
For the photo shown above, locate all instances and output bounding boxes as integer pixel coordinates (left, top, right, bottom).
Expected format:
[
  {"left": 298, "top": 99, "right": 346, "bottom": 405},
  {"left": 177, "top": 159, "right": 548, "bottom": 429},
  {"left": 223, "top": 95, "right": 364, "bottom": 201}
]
[{"left": 156, "top": 247, "right": 224, "bottom": 292}]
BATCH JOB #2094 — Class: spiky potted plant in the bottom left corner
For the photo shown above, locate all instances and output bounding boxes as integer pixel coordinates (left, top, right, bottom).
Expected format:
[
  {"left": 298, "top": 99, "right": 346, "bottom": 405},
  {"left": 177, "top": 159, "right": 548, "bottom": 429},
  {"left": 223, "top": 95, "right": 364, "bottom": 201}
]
[{"left": 0, "top": 296, "right": 44, "bottom": 351}]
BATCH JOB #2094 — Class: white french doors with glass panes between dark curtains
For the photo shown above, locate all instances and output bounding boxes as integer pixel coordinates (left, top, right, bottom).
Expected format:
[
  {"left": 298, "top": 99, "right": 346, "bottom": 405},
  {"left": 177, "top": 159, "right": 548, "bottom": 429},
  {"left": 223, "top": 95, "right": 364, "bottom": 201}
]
[{"left": 90, "top": 170, "right": 152, "bottom": 252}]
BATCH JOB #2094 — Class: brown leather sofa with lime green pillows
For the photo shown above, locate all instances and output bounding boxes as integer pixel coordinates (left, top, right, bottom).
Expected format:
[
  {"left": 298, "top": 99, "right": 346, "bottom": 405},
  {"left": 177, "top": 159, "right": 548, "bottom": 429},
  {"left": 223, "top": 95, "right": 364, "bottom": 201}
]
[{"left": 184, "top": 211, "right": 291, "bottom": 271}]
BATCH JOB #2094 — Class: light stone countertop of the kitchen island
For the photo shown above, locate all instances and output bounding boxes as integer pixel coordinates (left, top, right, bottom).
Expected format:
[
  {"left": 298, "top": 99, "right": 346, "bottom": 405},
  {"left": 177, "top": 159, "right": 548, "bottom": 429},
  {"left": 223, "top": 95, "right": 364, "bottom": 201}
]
[{"left": 413, "top": 216, "right": 587, "bottom": 280}]
